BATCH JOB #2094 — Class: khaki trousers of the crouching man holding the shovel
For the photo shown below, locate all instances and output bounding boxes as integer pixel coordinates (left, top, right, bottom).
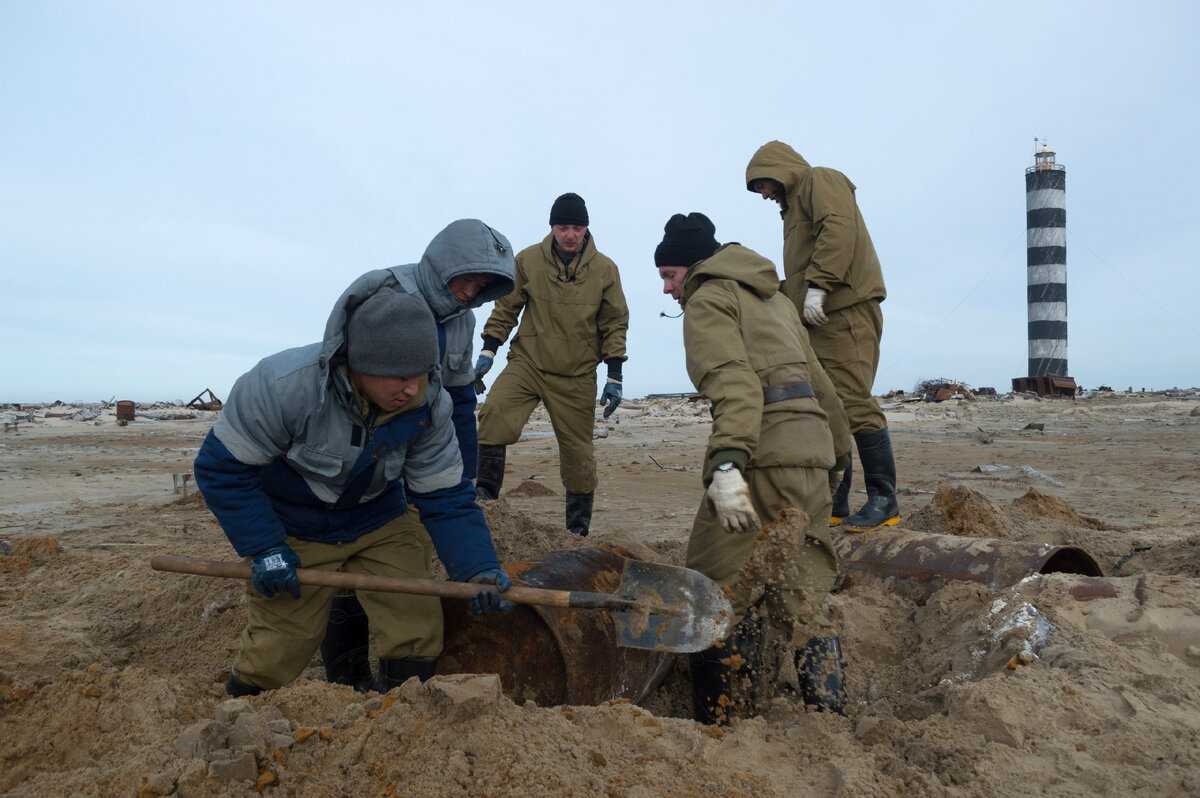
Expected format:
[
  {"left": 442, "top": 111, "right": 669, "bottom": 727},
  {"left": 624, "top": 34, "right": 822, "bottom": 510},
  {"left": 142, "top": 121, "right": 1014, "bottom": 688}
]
[{"left": 234, "top": 510, "right": 442, "bottom": 690}]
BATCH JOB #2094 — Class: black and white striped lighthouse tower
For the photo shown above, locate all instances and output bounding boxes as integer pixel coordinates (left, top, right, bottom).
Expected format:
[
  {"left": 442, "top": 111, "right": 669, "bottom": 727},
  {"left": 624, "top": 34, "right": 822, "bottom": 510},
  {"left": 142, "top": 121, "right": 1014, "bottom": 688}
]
[{"left": 1025, "top": 144, "right": 1067, "bottom": 377}]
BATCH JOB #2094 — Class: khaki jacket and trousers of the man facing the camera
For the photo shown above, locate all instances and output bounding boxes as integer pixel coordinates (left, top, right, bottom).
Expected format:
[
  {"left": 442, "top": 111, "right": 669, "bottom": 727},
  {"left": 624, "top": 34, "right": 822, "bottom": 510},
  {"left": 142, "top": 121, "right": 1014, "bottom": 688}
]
[{"left": 479, "top": 230, "right": 629, "bottom": 493}]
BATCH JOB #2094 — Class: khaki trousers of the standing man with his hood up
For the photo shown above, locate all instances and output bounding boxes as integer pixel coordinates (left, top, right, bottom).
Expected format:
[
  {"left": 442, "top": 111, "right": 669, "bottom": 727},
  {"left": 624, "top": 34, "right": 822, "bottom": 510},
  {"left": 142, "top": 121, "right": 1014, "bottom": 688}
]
[{"left": 806, "top": 300, "right": 888, "bottom": 434}]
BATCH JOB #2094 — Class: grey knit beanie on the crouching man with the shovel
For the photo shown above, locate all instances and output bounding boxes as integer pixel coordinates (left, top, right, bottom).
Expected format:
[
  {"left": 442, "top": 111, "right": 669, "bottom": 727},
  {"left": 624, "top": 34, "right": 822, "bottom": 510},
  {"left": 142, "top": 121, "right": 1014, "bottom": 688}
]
[{"left": 346, "top": 288, "right": 438, "bottom": 377}]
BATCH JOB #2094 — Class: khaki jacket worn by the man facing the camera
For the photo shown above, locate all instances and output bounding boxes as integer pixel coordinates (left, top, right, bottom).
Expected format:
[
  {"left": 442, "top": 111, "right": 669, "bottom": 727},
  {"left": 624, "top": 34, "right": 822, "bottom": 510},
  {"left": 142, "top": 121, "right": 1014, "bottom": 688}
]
[{"left": 484, "top": 235, "right": 629, "bottom": 377}]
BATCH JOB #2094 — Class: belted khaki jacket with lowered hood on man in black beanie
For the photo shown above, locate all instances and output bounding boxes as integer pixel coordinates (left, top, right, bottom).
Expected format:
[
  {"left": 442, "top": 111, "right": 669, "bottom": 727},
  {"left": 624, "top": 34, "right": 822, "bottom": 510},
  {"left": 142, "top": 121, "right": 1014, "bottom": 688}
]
[{"left": 683, "top": 244, "right": 834, "bottom": 485}]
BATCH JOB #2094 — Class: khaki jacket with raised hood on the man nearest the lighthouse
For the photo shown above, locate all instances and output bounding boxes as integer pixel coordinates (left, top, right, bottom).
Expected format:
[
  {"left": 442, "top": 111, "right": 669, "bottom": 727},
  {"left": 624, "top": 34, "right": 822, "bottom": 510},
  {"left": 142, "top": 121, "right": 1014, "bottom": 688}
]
[{"left": 746, "top": 142, "right": 888, "bottom": 313}]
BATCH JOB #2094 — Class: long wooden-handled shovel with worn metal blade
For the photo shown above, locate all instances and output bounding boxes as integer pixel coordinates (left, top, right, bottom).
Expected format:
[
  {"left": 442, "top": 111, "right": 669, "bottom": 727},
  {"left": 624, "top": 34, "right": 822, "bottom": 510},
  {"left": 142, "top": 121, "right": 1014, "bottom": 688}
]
[{"left": 150, "top": 556, "right": 733, "bottom": 654}]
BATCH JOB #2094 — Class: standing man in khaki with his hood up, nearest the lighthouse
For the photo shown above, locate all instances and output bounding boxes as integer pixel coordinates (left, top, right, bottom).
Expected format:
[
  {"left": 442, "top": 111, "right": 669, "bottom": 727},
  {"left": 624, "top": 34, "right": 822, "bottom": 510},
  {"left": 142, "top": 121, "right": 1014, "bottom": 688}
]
[{"left": 746, "top": 142, "right": 900, "bottom": 532}]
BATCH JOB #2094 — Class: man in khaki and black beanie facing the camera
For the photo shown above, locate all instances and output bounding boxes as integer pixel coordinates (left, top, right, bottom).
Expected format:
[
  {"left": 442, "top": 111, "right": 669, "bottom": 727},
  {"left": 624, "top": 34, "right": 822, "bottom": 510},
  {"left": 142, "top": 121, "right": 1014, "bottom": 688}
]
[{"left": 475, "top": 193, "right": 629, "bottom": 535}]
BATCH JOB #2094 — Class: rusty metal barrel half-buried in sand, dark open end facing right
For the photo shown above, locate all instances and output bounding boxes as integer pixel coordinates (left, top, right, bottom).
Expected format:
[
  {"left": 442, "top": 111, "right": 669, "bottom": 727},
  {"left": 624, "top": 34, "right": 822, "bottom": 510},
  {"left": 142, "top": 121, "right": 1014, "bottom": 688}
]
[{"left": 834, "top": 529, "right": 1104, "bottom": 595}]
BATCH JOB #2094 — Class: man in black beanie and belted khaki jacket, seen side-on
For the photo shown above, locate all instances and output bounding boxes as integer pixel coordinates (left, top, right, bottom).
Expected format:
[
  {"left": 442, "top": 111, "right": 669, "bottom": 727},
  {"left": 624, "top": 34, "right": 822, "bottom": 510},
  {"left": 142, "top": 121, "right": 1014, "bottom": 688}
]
[{"left": 654, "top": 212, "right": 844, "bottom": 724}]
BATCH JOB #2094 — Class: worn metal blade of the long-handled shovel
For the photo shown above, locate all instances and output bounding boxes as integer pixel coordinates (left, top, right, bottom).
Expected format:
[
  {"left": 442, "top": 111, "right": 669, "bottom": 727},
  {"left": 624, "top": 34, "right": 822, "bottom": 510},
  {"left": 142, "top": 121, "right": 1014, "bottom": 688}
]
[{"left": 612, "top": 559, "right": 733, "bottom": 654}]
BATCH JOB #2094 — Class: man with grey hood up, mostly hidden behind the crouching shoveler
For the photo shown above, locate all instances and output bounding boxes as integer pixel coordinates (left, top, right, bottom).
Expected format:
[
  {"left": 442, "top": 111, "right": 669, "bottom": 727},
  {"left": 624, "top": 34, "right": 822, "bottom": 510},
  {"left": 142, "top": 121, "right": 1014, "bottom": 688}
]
[{"left": 320, "top": 218, "right": 516, "bottom": 690}]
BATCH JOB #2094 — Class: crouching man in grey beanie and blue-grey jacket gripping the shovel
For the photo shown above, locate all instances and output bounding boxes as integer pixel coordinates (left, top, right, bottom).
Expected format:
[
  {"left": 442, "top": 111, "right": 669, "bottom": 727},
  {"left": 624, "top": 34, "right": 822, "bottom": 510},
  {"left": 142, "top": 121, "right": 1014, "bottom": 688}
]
[{"left": 194, "top": 287, "right": 512, "bottom": 696}]
